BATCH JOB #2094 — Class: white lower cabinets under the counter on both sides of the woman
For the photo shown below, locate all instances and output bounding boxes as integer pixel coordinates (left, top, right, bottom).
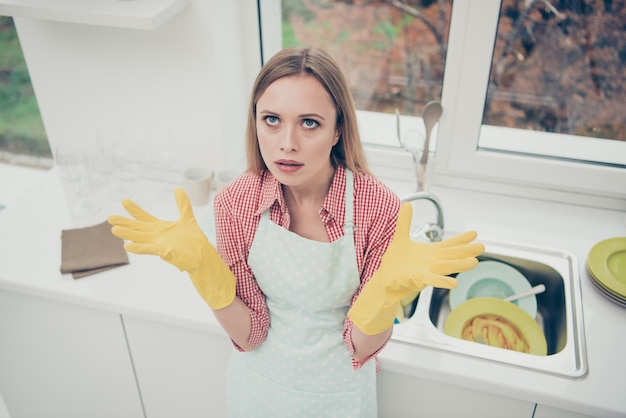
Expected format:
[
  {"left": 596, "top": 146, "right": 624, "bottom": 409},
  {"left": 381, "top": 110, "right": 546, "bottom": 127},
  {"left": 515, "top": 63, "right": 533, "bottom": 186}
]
[{"left": 0, "top": 291, "right": 600, "bottom": 418}]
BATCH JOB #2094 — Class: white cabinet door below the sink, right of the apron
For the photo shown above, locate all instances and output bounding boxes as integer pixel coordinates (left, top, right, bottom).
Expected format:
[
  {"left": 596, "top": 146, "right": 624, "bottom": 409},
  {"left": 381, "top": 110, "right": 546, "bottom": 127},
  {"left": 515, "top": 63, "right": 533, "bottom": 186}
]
[{"left": 378, "top": 370, "right": 535, "bottom": 418}]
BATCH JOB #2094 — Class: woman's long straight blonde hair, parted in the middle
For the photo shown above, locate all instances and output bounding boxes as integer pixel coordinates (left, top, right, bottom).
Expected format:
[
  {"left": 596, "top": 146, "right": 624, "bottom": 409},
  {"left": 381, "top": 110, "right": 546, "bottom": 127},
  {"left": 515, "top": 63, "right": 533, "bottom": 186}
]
[{"left": 246, "top": 47, "right": 369, "bottom": 173}]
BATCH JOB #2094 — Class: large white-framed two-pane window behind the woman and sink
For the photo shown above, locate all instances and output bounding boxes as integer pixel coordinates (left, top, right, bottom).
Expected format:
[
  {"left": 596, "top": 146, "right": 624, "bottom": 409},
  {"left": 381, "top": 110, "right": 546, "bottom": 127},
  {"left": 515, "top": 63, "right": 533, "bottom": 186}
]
[{"left": 260, "top": 0, "right": 626, "bottom": 210}]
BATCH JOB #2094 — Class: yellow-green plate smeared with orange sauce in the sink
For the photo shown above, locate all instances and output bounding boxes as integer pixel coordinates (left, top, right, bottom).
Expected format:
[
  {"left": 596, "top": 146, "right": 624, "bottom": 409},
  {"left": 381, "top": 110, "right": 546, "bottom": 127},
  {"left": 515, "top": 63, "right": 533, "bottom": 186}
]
[{"left": 443, "top": 298, "right": 548, "bottom": 356}]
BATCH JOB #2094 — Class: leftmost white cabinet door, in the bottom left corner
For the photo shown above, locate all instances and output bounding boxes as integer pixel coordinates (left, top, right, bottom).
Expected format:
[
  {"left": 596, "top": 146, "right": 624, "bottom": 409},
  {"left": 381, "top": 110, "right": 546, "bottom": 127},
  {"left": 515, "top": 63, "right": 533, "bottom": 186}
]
[{"left": 0, "top": 291, "right": 144, "bottom": 418}]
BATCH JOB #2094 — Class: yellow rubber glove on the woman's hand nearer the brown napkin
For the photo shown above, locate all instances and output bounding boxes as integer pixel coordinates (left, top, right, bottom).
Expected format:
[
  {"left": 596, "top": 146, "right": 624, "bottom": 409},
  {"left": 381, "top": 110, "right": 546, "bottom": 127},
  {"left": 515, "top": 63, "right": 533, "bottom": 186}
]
[{"left": 109, "top": 188, "right": 237, "bottom": 309}]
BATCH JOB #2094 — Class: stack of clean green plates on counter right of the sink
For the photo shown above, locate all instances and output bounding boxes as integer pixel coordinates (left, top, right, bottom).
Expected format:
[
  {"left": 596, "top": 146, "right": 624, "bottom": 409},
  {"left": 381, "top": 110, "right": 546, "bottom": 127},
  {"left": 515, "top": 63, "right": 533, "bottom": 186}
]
[{"left": 587, "top": 237, "right": 626, "bottom": 307}]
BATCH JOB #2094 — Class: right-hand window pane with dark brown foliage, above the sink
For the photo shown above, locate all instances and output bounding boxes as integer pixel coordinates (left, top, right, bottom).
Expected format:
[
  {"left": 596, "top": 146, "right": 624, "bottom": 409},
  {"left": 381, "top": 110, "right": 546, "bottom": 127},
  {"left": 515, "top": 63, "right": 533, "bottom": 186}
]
[{"left": 479, "top": 0, "right": 626, "bottom": 166}]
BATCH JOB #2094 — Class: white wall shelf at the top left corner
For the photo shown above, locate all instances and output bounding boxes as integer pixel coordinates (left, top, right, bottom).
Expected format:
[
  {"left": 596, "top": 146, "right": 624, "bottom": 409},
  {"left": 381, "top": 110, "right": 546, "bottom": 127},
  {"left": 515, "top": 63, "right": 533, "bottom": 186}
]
[{"left": 0, "top": 0, "right": 191, "bottom": 30}]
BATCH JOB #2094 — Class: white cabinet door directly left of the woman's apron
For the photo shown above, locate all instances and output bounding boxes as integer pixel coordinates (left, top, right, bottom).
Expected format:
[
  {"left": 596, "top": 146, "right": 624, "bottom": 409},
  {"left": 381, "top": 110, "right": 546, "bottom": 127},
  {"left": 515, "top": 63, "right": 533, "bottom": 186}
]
[{"left": 124, "top": 316, "right": 234, "bottom": 418}]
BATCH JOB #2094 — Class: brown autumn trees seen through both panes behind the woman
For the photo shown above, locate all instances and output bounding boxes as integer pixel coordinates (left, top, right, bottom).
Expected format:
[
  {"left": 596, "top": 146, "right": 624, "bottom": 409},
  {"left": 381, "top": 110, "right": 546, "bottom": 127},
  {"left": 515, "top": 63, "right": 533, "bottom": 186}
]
[{"left": 282, "top": 0, "right": 626, "bottom": 155}]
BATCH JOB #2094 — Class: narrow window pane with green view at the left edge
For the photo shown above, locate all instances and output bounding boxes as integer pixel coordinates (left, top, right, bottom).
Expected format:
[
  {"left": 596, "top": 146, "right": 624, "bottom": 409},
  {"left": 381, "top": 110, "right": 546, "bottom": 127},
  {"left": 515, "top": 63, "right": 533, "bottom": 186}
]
[{"left": 0, "top": 16, "right": 52, "bottom": 168}]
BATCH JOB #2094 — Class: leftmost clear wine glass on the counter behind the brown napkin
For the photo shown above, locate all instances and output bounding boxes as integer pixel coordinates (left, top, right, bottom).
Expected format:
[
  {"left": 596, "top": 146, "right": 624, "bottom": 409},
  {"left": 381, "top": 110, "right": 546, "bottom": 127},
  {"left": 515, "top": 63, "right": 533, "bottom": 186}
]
[{"left": 55, "top": 143, "right": 100, "bottom": 217}]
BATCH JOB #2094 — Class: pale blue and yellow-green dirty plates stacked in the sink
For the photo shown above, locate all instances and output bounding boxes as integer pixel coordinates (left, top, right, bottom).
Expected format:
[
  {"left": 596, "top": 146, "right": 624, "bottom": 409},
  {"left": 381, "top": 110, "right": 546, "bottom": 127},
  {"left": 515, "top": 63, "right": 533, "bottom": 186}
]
[{"left": 444, "top": 261, "right": 547, "bottom": 356}]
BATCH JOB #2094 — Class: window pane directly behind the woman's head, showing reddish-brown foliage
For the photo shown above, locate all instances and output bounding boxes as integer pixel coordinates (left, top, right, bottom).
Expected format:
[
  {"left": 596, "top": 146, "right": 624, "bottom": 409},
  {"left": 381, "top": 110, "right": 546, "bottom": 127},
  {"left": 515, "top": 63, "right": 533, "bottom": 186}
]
[{"left": 261, "top": 0, "right": 451, "bottom": 147}]
